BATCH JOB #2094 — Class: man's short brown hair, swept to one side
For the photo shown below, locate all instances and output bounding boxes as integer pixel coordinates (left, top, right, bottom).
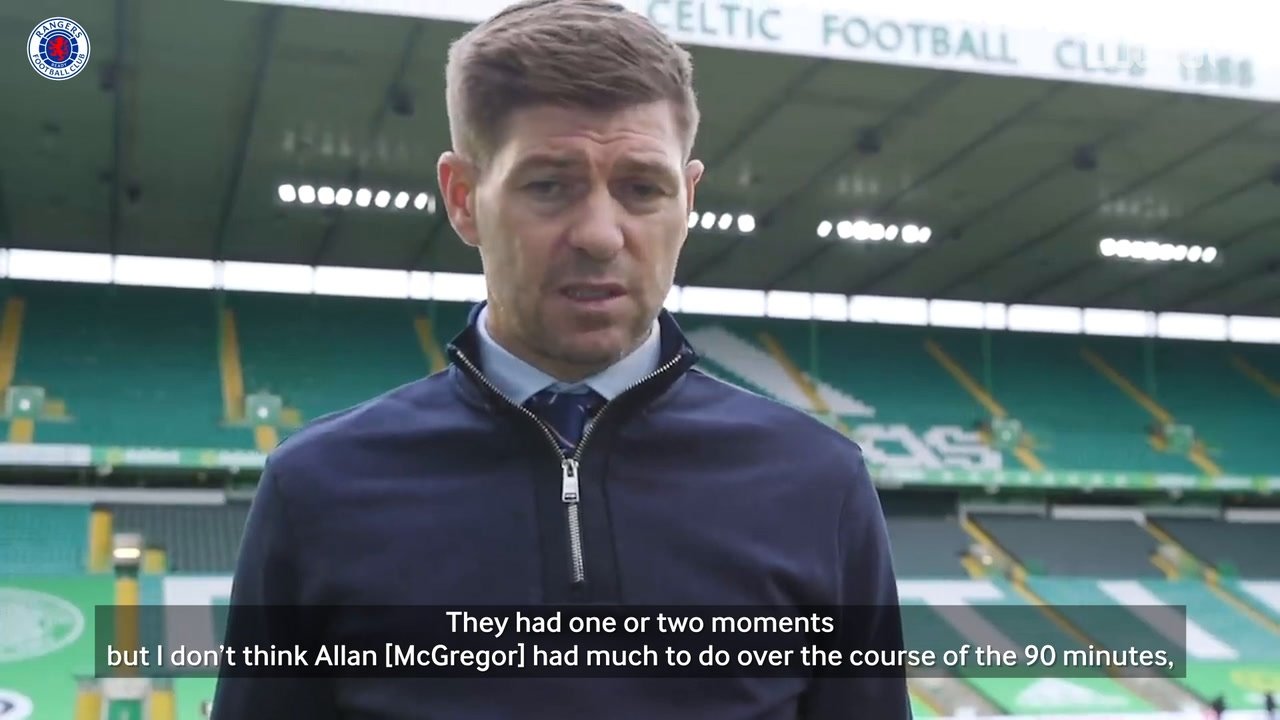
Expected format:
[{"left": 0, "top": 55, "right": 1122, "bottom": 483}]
[{"left": 445, "top": 0, "right": 699, "bottom": 165}]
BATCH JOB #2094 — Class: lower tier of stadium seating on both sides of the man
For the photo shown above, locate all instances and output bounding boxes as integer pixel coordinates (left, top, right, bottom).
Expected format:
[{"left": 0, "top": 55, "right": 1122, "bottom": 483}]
[{"left": 0, "top": 491, "right": 1280, "bottom": 720}]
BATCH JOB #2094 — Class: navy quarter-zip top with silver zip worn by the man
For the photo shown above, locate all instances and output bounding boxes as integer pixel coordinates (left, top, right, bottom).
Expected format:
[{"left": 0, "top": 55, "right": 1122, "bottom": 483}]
[{"left": 214, "top": 309, "right": 910, "bottom": 720}]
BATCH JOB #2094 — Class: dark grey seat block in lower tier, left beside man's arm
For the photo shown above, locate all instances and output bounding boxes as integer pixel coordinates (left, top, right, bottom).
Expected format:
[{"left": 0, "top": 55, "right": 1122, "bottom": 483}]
[{"left": 109, "top": 502, "right": 248, "bottom": 573}]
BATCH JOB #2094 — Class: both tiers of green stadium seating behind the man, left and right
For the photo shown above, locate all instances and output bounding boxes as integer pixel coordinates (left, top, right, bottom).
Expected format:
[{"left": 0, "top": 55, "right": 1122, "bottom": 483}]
[{"left": 0, "top": 283, "right": 1280, "bottom": 720}]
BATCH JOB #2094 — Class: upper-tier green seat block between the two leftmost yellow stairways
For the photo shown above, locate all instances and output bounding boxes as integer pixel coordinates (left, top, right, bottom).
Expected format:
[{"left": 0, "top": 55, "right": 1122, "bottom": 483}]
[{"left": 9, "top": 282, "right": 250, "bottom": 447}]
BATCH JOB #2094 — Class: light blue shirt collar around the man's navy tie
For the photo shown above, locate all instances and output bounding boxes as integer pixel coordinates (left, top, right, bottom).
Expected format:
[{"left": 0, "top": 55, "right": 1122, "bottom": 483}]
[{"left": 476, "top": 305, "right": 662, "bottom": 405}]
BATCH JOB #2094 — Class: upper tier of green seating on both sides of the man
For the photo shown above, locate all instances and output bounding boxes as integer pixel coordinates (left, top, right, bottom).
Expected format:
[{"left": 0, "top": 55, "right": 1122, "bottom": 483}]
[{"left": 8, "top": 288, "right": 1277, "bottom": 484}]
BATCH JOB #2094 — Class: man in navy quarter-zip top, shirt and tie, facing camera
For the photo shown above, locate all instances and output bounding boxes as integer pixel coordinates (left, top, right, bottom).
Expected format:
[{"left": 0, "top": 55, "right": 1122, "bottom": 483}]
[{"left": 214, "top": 0, "right": 910, "bottom": 720}]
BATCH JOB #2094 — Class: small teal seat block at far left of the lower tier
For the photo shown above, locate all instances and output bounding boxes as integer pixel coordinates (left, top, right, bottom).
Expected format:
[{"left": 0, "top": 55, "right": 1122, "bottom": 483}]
[{"left": 0, "top": 502, "right": 90, "bottom": 577}]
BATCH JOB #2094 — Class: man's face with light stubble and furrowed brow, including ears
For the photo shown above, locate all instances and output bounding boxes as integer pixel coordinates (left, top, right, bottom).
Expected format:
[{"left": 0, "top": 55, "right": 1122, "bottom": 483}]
[{"left": 439, "top": 102, "right": 703, "bottom": 379}]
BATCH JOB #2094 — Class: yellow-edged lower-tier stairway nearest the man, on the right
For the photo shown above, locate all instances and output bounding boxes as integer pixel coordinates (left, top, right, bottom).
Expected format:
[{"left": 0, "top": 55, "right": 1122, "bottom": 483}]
[{"left": 961, "top": 515, "right": 1201, "bottom": 710}]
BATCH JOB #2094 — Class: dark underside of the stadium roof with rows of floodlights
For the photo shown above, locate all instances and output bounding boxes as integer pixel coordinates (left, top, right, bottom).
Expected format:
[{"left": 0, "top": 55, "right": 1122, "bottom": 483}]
[{"left": 0, "top": 0, "right": 1280, "bottom": 315}]
